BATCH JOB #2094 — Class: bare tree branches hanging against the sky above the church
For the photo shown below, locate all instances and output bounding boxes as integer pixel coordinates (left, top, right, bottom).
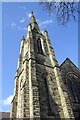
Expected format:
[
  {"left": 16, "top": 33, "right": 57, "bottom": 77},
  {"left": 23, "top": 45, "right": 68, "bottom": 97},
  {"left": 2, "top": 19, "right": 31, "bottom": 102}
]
[{"left": 40, "top": 0, "right": 80, "bottom": 25}]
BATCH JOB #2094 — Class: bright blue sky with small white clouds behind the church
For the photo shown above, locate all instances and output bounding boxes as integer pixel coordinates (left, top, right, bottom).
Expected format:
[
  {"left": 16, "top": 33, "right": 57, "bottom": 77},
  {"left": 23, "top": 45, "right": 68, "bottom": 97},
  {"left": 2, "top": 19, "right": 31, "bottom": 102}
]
[{"left": 0, "top": 2, "right": 78, "bottom": 111}]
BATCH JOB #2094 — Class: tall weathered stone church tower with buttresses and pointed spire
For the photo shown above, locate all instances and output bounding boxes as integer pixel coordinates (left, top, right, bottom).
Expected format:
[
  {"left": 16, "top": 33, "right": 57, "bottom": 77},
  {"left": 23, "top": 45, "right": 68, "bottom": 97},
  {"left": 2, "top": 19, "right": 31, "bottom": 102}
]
[{"left": 10, "top": 12, "right": 74, "bottom": 119}]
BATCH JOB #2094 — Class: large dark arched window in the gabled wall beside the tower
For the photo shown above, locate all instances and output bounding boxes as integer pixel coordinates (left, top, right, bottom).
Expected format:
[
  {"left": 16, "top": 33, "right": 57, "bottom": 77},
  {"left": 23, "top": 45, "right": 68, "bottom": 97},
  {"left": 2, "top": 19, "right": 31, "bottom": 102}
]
[{"left": 67, "top": 73, "right": 80, "bottom": 103}]
